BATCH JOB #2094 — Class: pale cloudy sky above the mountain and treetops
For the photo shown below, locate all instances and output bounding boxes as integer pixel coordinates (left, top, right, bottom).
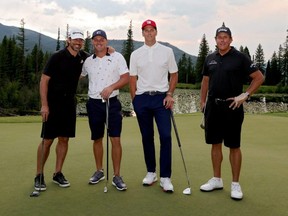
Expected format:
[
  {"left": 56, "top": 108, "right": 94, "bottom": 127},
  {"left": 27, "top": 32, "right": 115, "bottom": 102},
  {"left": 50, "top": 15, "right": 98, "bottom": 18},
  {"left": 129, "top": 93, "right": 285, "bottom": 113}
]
[{"left": 0, "top": 0, "right": 288, "bottom": 61}]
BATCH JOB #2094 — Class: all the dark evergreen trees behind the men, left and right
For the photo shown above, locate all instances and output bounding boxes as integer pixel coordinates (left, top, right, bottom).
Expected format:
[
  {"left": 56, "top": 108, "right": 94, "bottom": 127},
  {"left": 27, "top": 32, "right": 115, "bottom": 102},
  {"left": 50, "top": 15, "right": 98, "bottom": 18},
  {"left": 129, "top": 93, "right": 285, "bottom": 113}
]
[{"left": 0, "top": 19, "right": 288, "bottom": 115}]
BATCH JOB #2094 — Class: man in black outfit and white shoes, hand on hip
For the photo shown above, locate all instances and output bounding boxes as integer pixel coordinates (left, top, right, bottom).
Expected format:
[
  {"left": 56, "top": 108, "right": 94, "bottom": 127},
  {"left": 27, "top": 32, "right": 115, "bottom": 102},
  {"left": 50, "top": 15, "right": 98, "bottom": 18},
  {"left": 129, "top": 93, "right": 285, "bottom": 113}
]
[{"left": 200, "top": 23, "right": 264, "bottom": 200}]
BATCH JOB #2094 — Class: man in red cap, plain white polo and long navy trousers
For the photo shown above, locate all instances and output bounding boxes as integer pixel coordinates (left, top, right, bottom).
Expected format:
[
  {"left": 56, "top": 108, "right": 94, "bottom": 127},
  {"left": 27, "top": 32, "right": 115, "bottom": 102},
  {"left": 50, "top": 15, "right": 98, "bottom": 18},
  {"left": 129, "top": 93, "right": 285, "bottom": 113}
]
[{"left": 130, "top": 20, "right": 178, "bottom": 192}]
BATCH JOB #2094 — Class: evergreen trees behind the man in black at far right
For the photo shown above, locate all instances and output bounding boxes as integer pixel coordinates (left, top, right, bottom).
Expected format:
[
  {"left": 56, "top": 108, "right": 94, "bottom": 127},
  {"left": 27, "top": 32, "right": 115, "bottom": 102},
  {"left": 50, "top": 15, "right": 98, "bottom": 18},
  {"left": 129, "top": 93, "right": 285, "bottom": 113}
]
[{"left": 178, "top": 30, "right": 288, "bottom": 88}]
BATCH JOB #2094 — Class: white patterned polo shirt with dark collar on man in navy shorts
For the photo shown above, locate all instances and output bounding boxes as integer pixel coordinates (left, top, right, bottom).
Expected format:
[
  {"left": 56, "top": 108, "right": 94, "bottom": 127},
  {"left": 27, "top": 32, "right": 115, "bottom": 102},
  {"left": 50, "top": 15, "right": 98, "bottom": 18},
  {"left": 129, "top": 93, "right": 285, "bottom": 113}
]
[{"left": 81, "top": 52, "right": 129, "bottom": 99}]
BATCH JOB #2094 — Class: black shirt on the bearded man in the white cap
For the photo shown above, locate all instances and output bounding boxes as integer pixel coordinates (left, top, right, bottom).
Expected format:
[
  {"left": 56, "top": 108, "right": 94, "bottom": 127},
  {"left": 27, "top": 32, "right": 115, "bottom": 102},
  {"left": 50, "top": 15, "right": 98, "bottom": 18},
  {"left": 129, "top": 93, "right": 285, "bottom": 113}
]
[{"left": 43, "top": 47, "right": 89, "bottom": 97}]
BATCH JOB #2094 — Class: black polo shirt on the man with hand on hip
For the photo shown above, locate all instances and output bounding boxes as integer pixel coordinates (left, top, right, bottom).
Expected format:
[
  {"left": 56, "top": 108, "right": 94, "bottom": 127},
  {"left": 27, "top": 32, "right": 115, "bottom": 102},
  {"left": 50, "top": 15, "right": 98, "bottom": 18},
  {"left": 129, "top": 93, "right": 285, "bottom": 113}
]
[{"left": 202, "top": 47, "right": 258, "bottom": 99}]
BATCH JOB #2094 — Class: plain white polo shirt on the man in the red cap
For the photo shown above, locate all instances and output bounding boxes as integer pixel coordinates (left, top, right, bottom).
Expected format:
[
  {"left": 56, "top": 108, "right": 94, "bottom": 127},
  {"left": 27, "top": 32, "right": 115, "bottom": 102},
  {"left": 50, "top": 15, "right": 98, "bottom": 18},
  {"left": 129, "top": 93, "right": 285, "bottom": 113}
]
[{"left": 129, "top": 42, "right": 178, "bottom": 95}]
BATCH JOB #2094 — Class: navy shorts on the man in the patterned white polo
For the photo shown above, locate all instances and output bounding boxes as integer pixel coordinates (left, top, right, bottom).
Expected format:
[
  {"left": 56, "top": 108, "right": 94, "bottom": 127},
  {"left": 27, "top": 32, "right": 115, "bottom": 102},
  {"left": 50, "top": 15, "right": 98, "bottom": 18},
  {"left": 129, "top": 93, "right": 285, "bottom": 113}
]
[{"left": 86, "top": 96, "right": 123, "bottom": 140}]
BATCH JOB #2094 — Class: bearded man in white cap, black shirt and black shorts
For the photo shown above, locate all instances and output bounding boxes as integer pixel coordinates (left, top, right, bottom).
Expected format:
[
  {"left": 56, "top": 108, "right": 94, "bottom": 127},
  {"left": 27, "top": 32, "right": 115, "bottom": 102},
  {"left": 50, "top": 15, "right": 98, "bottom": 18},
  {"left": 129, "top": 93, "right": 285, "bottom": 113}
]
[{"left": 34, "top": 30, "right": 89, "bottom": 191}]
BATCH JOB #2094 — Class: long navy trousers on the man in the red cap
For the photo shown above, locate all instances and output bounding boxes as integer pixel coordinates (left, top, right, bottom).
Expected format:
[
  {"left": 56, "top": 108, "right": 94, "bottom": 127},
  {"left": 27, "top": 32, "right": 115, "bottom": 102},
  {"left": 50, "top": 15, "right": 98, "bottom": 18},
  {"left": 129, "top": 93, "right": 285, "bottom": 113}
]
[{"left": 133, "top": 94, "right": 172, "bottom": 178}]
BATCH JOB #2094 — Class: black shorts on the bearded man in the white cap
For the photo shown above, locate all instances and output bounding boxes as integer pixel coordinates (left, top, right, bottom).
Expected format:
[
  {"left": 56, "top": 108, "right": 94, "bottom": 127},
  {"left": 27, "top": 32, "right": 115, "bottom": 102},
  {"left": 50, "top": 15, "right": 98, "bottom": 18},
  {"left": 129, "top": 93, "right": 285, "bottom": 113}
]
[{"left": 41, "top": 96, "right": 76, "bottom": 139}]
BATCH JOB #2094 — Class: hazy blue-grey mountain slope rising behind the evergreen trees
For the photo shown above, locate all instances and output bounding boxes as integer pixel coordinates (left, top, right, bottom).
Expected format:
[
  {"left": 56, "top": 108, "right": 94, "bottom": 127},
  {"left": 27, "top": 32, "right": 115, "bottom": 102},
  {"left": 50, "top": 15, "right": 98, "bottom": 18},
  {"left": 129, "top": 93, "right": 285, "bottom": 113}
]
[{"left": 0, "top": 23, "right": 197, "bottom": 63}]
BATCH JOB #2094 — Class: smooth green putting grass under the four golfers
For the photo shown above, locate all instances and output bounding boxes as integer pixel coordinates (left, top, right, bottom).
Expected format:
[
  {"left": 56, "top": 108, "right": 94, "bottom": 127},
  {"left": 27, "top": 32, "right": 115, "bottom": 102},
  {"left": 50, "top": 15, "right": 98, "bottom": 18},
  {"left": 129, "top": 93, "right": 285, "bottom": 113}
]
[{"left": 0, "top": 113, "right": 288, "bottom": 216}]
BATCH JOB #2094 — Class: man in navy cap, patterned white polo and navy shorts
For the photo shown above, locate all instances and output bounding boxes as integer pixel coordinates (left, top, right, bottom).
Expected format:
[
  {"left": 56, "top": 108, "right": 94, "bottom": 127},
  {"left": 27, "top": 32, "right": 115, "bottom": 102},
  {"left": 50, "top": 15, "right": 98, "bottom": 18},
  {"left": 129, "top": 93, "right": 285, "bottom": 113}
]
[{"left": 81, "top": 29, "right": 129, "bottom": 191}]
